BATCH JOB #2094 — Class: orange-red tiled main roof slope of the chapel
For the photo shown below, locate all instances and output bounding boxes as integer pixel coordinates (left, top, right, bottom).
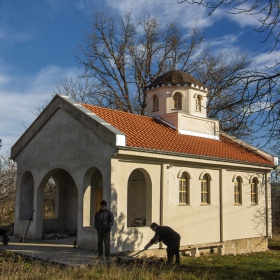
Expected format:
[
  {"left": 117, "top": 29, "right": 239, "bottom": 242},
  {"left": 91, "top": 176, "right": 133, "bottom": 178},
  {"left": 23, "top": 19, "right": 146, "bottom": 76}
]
[{"left": 82, "top": 104, "right": 273, "bottom": 165}]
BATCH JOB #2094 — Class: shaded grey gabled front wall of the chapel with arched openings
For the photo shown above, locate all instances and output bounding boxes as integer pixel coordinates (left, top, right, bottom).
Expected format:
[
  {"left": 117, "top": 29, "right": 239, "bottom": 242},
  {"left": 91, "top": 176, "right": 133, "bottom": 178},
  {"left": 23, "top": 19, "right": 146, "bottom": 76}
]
[{"left": 15, "top": 109, "right": 115, "bottom": 249}]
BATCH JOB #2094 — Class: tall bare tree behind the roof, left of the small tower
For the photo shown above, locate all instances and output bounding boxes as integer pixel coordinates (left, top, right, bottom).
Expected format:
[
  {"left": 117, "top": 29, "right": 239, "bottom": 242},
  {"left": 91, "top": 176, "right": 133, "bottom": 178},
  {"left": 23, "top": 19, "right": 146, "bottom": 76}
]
[{"left": 76, "top": 13, "right": 206, "bottom": 115}]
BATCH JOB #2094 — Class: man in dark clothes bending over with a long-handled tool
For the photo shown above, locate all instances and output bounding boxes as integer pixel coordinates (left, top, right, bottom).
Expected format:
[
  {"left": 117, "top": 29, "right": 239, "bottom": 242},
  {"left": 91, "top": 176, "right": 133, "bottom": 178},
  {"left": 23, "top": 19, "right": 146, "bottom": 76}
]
[{"left": 144, "top": 223, "right": 181, "bottom": 265}]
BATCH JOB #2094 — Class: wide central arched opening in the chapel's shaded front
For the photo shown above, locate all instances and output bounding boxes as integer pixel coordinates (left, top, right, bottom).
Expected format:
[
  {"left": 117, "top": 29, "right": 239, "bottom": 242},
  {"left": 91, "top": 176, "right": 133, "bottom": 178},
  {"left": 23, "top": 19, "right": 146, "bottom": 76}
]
[{"left": 36, "top": 169, "right": 78, "bottom": 238}]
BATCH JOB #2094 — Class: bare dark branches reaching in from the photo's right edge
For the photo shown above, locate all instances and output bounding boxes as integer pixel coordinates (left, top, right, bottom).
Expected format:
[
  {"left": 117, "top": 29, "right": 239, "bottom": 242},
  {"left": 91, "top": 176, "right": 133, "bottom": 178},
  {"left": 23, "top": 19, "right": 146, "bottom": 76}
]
[{"left": 177, "top": 0, "right": 280, "bottom": 145}]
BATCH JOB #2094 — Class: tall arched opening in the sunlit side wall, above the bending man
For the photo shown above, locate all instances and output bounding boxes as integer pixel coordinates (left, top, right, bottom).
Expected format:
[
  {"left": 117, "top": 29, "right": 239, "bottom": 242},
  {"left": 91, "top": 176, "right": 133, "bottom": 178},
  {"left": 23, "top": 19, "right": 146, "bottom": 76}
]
[{"left": 127, "top": 169, "right": 152, "bottom": 227}]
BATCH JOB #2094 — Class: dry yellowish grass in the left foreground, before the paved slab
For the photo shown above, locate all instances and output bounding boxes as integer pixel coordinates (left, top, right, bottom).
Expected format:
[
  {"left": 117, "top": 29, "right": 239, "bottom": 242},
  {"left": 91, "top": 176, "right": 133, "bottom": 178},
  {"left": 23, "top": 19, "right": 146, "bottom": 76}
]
[{"left": 0, "top": 251, "right": 195, "bottom": 280}]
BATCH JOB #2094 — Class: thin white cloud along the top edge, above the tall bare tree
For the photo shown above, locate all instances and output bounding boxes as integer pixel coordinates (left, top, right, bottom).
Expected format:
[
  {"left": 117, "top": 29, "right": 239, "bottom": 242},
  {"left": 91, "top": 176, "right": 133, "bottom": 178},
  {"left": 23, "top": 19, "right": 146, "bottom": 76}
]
[{"left": 106, "top": 0, "right": 270, "bottom": 31}]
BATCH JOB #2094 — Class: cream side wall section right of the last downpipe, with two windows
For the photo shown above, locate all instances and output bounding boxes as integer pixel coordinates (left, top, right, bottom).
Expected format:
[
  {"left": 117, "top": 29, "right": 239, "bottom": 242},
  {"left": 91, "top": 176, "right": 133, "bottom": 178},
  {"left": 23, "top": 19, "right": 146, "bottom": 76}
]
[{"left": 223, "top": 170, "right": 271, "bottom": 241}]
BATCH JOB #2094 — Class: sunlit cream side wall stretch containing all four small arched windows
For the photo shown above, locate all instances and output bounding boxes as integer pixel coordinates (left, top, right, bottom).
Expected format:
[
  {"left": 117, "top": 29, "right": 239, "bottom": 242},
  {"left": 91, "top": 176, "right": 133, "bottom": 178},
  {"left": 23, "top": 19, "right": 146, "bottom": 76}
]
[{"left": 164, "top": 165, "right": 271, "bottom": 245}]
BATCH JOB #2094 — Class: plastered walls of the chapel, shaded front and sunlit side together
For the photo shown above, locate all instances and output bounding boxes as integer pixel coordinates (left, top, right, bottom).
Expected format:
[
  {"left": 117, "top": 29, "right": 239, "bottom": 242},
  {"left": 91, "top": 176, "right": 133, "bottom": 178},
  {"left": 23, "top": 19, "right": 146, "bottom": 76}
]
[{"left": 12, "top": 101, "right": 271, "bottom": 252}]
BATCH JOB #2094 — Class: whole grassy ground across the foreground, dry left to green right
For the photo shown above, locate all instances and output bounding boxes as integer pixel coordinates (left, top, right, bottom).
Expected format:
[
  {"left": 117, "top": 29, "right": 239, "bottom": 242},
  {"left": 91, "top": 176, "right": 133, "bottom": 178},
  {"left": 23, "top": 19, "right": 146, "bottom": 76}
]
[{"left": 0, "top": 236, "right": 280, "bottom": 280}]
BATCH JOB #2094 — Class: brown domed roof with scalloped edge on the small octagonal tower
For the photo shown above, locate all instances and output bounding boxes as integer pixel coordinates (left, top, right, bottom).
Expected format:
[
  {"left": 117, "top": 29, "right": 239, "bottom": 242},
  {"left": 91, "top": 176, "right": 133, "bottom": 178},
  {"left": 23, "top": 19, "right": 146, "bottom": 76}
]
[{"left": 147, "top": 70, "right": 206, "bottom": 90}]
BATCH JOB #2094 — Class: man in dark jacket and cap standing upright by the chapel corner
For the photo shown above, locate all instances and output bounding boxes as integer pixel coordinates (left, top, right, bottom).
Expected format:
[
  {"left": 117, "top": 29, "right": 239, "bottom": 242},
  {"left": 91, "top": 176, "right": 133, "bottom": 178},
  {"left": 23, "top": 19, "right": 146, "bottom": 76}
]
[{"left": 94, "top": 200, "right": 114, "bottom": 260}]
